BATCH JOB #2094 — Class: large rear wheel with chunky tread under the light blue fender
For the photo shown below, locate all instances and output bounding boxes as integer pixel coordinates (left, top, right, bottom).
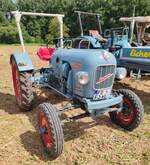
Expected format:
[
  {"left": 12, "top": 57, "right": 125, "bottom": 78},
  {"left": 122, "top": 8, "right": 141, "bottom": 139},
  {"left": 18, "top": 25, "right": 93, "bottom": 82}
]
[{"left": 11, "top": 58, "right": 34, "bottom": 111}]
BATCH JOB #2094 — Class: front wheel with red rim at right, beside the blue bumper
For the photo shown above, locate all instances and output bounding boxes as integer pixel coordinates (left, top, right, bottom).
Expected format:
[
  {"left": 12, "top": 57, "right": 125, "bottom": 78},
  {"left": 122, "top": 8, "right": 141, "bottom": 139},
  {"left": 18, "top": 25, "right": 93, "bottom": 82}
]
[{"left": 109, "top": 89, "right": 144, "bottom": 131}]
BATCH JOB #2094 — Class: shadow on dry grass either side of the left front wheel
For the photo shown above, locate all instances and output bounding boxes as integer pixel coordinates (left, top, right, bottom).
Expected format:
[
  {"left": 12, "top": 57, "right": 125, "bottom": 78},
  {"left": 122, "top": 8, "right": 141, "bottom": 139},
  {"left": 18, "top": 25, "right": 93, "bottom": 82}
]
[{"left": 20, "top": 113, "right": 118, "bottom": 161}]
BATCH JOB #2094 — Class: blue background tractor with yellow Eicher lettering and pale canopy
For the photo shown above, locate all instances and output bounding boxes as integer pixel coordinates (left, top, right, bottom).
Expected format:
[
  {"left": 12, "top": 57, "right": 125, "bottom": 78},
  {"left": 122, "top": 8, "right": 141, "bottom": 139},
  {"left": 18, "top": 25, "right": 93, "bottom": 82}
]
[{"left": 104, "top": 16, "right": 150, "bottom": 78}]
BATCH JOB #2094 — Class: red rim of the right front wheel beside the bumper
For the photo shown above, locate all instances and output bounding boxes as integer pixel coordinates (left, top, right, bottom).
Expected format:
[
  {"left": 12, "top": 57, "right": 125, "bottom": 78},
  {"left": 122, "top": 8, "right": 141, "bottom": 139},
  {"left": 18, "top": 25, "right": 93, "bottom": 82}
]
[{"left": 117, "top": 96, "right": 136, "bottom": 125}]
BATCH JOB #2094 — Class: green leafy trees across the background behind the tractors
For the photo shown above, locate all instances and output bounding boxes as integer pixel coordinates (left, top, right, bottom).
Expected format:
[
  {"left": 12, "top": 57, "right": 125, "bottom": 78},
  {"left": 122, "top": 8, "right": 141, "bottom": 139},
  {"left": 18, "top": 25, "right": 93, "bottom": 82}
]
[{"left": 0, "top": 0, "right": 150, "bottom": 43}]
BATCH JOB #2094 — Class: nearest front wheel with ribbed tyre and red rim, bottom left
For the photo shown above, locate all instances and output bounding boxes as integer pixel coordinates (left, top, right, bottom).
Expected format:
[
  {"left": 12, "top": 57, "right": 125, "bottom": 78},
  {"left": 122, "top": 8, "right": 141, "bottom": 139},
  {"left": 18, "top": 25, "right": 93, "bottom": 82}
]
[{"left": 38, "top": 103, "right": 64, "bottom": 159}]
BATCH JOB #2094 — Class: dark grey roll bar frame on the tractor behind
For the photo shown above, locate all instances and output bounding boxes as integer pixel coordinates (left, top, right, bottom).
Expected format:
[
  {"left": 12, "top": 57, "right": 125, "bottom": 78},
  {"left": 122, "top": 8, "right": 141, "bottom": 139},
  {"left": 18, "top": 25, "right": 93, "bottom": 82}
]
[{"left": 75, "top": 11, "right": 102, "bottom": 36}]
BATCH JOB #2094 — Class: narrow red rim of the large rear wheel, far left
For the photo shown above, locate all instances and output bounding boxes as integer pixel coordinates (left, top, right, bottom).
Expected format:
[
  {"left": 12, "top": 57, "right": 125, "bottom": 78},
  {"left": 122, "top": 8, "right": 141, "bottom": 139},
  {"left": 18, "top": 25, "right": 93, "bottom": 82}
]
[{"left": 12, "top": 62, "right": 21, "bottom": 103}]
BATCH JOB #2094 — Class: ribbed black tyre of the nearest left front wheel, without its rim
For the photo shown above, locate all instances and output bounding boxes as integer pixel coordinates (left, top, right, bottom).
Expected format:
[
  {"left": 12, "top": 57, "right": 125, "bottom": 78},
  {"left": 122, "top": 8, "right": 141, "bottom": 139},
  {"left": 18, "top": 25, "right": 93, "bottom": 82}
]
[{"left": 38, "top": 103, "right": 64, "bottom": 160}]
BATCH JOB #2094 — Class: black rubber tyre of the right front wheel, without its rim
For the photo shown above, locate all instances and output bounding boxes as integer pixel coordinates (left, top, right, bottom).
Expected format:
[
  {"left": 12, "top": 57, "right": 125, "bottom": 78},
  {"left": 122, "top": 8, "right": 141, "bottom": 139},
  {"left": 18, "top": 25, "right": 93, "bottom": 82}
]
[{"left": 109, "top": 89, "right": 144, "bottom": 131}]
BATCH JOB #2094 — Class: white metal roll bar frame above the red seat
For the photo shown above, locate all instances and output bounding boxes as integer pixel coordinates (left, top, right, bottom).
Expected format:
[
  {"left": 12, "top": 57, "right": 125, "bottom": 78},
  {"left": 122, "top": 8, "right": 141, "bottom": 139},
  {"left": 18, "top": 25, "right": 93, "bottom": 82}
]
[{"left": 11, "top": 10, "right": 64, "bottom": 52}]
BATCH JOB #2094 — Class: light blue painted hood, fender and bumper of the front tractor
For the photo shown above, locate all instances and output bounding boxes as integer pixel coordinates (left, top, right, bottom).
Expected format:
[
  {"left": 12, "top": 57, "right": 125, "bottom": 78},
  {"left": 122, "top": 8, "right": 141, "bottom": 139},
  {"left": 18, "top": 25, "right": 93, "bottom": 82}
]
[{"left": 11, "top": 43, "right": 122, "bottom": 115}]
